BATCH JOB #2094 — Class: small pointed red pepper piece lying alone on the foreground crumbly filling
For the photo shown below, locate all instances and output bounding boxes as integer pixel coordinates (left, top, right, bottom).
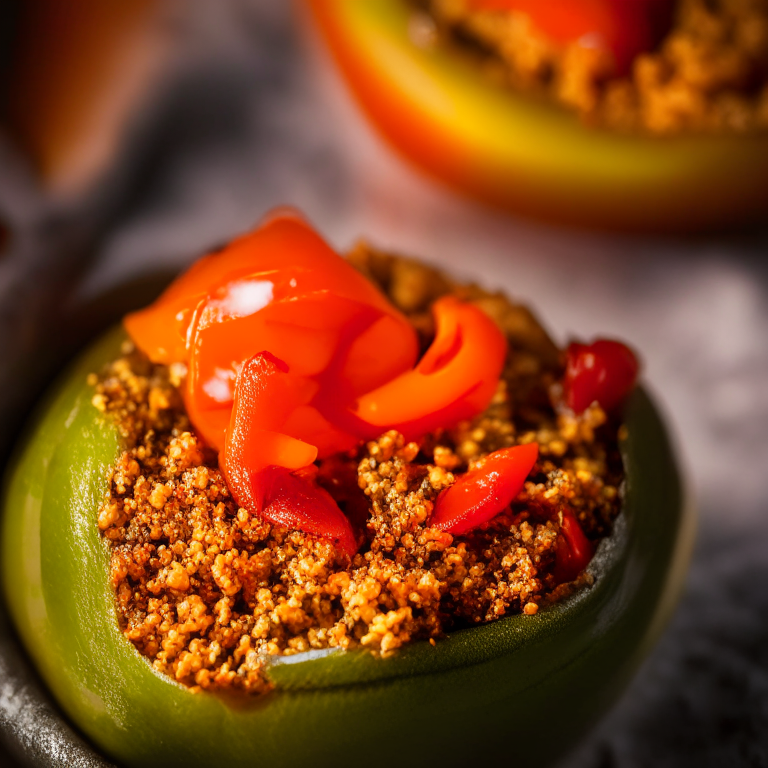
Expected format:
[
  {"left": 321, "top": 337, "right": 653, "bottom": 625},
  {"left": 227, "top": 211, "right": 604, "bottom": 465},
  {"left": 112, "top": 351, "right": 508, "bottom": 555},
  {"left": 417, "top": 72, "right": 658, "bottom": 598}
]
[{"left": 430, "top": 443, "right": 539, "bottom": 535}]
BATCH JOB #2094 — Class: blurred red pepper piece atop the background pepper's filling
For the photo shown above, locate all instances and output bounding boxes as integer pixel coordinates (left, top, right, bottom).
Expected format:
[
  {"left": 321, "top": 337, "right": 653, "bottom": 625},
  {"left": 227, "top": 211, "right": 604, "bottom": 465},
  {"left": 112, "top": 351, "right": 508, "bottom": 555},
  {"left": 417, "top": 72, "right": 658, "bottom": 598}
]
[{"left": 464, "top": 0, "right": 672, "bottom": 75}]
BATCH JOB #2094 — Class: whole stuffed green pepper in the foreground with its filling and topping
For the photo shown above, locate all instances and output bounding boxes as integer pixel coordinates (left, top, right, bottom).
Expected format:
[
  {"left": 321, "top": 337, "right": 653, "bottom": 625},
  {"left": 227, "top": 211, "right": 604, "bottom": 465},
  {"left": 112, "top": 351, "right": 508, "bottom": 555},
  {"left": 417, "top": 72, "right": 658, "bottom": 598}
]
[{"left": 2, "top": 214, "right": 691, "bottom": 767}]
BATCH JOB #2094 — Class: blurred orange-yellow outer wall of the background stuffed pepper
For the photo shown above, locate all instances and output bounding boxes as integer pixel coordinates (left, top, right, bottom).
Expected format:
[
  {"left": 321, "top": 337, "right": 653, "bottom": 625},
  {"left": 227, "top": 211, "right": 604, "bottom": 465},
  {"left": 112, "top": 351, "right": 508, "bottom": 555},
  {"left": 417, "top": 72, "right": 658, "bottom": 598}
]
[{"left": 307, "top": 0, "right": 768, "bottom": 232}]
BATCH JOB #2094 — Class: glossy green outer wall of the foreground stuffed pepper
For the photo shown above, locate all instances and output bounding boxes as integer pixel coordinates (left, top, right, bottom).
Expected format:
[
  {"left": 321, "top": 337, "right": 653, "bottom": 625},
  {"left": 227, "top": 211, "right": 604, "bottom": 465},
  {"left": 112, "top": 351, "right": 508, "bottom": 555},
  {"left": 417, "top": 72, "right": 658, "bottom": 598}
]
[{"left": 1, "top": 330, "right": 693, "bottom": 768}]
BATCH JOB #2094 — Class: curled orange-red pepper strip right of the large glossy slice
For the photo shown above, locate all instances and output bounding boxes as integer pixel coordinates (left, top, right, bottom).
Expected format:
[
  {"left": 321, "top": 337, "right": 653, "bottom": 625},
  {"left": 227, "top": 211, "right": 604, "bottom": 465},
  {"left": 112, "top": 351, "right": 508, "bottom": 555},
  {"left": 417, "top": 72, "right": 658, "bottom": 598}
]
[{"left": 351, "top": 297, "right": 507, "bottom": 439}]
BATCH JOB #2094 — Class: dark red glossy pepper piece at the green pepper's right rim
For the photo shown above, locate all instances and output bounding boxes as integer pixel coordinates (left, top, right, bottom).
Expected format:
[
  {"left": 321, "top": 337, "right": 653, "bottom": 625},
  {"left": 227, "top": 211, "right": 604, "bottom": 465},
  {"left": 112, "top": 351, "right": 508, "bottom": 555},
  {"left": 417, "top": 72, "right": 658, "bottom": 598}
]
[{"left": 563, "top": 339, "right": 640, "bottom": 413}]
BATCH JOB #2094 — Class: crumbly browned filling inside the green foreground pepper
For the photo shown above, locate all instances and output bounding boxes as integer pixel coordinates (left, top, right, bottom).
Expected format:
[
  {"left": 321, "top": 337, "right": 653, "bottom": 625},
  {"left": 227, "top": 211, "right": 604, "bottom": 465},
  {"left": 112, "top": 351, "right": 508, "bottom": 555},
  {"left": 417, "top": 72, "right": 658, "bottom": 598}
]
[{"left": 91, "top": 245, "right": 622, "bottom": 693}]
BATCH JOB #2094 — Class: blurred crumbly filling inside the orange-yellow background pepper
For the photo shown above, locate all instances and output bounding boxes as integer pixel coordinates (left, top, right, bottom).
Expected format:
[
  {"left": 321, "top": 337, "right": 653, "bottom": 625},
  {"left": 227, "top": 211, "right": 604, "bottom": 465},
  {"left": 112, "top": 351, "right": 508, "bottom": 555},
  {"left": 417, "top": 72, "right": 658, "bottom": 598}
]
[{"left": 414, "top": 0, "right": 768, "bottom": 135}]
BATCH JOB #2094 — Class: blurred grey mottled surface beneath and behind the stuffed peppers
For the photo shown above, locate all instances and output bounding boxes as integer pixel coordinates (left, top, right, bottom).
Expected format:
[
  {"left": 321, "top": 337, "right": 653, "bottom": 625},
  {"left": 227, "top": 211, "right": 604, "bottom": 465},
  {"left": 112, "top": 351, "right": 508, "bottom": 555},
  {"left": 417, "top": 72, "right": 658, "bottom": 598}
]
[{"left": 0, "top": 0, "right": 768, "bottom": 768}]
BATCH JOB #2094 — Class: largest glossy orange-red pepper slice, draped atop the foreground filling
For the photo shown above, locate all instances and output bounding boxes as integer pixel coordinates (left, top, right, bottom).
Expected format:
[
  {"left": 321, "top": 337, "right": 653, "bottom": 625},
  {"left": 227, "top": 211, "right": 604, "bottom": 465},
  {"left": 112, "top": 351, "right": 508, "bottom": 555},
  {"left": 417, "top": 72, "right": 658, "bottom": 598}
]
[{"left": 125, "top": 213, "right": 418, "bottom": 455}]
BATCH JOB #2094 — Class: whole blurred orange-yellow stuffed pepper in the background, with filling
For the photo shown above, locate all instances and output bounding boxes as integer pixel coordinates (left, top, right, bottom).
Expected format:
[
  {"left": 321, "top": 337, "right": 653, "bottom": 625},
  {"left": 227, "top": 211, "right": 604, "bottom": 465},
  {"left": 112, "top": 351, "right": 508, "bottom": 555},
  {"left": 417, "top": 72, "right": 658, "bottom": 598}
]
[{"left": 308, "top": 0, "right": 768, "bottom": 231}]
